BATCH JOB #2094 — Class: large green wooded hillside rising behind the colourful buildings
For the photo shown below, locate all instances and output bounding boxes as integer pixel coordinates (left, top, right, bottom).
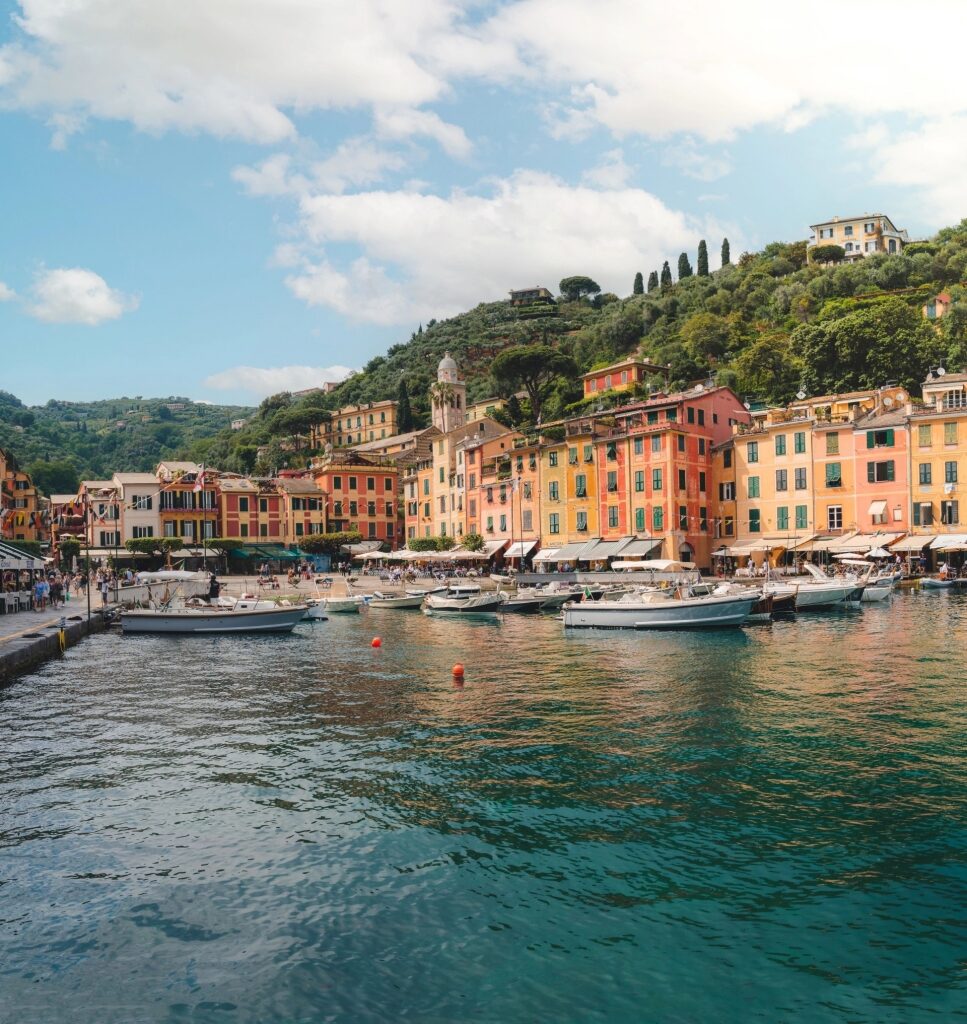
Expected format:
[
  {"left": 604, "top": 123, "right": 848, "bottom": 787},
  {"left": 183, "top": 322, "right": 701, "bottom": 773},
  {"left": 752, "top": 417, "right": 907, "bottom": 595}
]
[{"left": 191, "top": 221, "right": 967, "bottom": 471}]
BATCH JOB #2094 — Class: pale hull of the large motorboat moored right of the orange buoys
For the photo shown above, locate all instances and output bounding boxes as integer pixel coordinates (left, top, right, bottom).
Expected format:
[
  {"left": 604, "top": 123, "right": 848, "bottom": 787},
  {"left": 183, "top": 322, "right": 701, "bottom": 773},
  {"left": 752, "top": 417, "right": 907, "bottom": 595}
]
[{"left": 563, "top": 592, "right": 760, "bottom": 630}]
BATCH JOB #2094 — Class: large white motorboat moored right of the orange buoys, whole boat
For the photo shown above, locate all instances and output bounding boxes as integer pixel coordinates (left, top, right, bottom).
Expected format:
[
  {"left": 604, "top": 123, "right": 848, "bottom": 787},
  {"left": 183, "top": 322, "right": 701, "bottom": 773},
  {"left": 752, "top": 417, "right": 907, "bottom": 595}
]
[{"left": 563, "top": 585, "right": 762, "bottom": 630}]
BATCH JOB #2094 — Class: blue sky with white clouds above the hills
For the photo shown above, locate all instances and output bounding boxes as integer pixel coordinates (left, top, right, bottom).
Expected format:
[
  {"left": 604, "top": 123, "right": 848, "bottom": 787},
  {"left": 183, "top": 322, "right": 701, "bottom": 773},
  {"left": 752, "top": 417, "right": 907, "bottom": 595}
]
[{"left": 0, "top": 0, "right": 967, "bottom": 404}]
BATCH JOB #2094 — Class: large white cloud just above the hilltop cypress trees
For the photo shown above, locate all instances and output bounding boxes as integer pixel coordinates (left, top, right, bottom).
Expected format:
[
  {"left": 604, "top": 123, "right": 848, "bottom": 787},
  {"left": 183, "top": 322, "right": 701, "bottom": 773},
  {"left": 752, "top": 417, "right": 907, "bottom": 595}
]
[{"left": 276, "top": 171, "right": 729, "bottom": 324}]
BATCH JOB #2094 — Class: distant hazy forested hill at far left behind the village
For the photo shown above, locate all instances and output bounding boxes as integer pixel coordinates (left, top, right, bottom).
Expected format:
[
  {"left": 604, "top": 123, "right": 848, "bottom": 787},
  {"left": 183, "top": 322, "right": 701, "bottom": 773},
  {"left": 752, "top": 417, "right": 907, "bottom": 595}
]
[{"left": 0, "top": 391, "right": 254, "bottom": 495}]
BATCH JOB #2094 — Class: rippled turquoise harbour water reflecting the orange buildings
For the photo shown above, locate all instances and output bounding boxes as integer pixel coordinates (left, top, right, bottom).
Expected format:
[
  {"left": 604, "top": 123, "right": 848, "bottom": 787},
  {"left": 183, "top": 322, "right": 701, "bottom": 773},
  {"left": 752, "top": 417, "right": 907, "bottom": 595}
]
[{"left": 0, "top": 593, "right": 967, "bottom": 1024}]
